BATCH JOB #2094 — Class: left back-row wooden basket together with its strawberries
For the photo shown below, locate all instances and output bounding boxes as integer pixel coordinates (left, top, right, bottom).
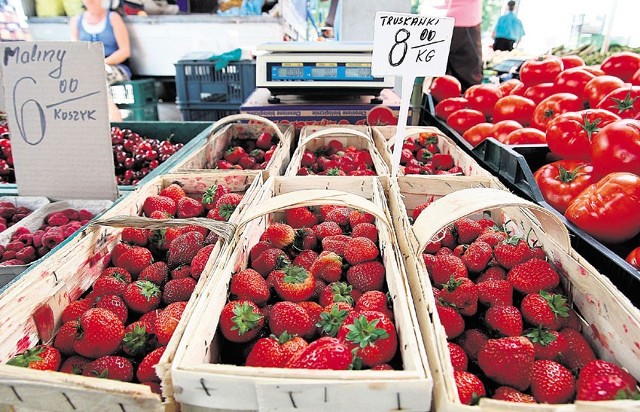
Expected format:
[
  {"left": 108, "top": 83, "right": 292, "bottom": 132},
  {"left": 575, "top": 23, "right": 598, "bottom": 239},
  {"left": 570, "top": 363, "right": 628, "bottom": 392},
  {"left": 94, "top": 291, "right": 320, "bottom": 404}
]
[{"left": 167, "top": 114, "right": 295, "bottom": 176}]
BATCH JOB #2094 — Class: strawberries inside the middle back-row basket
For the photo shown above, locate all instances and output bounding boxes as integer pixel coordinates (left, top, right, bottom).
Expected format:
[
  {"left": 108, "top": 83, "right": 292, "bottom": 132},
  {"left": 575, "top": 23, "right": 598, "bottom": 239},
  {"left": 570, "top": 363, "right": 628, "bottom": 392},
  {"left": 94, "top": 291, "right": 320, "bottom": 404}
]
[{"left": 297, "top": 139, "right": 376, "bottom": 176}]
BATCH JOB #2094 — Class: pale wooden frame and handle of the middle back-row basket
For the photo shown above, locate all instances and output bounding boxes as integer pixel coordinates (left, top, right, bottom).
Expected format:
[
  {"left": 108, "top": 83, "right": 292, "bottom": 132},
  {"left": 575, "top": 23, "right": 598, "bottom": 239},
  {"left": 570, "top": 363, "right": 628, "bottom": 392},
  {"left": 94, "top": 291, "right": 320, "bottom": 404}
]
[{"left": 285, "top": 126, "right": 389, "bottom": 176}]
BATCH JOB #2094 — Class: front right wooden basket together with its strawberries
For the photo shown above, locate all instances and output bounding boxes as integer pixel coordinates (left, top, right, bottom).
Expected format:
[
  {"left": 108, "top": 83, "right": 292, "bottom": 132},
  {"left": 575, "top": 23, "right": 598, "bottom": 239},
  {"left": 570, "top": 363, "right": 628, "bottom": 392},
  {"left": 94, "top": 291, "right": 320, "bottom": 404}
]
[{"left": 389, "top": 182, "right": 640, "bottom": 411}]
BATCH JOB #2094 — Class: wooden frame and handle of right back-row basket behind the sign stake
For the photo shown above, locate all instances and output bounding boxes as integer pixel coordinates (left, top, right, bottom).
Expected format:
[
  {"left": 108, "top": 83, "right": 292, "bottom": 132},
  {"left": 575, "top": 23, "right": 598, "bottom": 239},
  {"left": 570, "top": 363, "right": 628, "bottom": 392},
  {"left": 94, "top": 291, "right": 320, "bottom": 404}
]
[{"left": 371, "top": 126, "right": 491, "bottom": 177}]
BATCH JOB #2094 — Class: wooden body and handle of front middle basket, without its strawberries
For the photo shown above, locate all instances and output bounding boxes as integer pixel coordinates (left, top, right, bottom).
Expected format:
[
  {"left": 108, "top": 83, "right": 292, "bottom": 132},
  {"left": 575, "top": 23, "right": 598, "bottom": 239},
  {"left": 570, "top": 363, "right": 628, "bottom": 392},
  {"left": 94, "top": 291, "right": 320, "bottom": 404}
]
[{"left": 171, "top": 177, "right": 431, "bottom": 411}]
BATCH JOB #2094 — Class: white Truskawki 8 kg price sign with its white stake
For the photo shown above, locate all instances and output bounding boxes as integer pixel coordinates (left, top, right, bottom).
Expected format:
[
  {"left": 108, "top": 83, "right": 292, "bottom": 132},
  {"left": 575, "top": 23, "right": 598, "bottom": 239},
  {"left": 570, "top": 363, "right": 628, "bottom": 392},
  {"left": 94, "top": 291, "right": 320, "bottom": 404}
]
[{"left": 371, "top": 11, "right": 454, "bottom": 176}]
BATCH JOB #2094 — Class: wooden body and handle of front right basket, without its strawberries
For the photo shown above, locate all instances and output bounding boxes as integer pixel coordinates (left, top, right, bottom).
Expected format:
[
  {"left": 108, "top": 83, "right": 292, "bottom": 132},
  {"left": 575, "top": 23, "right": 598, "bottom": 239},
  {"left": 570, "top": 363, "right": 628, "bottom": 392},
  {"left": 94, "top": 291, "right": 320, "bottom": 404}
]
[{"left": 389, "top": 185, "right": 640, "bottom": 411}]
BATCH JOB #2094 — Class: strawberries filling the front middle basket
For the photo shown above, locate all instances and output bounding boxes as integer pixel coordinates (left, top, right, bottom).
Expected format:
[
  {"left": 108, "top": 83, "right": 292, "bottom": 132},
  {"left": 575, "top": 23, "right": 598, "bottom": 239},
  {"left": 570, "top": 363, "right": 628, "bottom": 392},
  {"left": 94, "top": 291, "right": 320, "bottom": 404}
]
[{"left": 219, "top": 205, "right": 401, "bottom": 370}]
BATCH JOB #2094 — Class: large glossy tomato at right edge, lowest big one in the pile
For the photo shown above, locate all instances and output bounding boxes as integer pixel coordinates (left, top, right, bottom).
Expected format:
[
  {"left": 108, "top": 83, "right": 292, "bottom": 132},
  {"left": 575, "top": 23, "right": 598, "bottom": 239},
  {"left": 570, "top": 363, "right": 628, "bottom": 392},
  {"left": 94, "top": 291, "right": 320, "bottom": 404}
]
[{"left": 564, "top": 173, "right": 640, "bottom": 243}]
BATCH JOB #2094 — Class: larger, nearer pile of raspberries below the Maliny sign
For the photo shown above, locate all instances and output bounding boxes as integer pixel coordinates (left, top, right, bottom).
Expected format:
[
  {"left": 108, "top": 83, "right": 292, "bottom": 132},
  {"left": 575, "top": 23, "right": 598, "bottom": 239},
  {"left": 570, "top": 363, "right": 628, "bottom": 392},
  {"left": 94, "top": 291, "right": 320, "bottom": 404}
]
[{"left": 0, "top": 209, "right": 93, "bottom": 266}]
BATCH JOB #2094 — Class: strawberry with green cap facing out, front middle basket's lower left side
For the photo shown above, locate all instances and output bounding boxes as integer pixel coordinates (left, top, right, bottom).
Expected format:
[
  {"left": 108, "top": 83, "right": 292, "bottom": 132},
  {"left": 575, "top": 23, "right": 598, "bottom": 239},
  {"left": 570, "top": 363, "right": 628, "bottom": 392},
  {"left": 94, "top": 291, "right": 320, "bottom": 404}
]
[{"left": 220, "top": 300, "right": 264, "bottom": 343}]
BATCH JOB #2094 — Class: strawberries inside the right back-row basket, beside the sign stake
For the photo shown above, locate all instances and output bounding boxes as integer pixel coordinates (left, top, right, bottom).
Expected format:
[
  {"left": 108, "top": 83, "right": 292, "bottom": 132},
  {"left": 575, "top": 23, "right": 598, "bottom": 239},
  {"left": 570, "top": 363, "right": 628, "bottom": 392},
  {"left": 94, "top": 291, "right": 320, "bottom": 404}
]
[{"left": 400, "top": 133, "right": 462, "bottom": 175}]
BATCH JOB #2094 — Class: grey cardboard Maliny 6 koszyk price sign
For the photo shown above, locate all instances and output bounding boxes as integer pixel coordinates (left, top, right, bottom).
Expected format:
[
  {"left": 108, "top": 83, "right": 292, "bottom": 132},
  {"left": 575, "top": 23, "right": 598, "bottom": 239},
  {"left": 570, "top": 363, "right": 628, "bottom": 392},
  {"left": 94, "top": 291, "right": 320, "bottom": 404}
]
[{"left": 0, "top": 42, "right": 118, "bottom": 200}]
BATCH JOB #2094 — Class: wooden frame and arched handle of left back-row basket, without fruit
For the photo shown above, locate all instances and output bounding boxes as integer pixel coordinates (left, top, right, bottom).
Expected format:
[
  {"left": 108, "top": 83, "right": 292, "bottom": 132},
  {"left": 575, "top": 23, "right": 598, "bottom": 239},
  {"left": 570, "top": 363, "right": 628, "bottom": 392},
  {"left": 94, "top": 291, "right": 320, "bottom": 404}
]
[{"left": 167, "top": 114, "right": 295, "bottom": 176}]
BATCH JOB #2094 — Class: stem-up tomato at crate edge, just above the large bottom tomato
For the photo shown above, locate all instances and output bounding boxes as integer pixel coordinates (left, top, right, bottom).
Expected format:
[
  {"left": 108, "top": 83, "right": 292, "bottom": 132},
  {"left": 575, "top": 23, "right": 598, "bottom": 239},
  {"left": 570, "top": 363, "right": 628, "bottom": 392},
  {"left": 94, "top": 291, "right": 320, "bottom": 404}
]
[{"left": 533, "top": 160, "right": 598, "bottom": 214}]
